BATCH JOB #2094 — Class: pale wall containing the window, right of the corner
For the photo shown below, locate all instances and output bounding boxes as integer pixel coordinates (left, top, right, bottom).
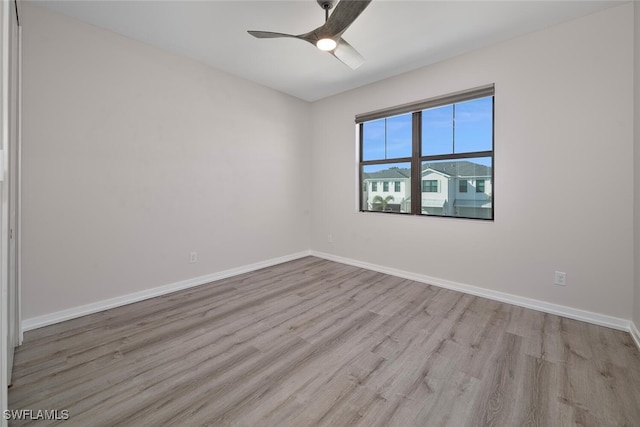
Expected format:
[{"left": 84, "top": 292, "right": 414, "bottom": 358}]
[{"left": 311, "top": 4, "right": 634, "bottom": 319}]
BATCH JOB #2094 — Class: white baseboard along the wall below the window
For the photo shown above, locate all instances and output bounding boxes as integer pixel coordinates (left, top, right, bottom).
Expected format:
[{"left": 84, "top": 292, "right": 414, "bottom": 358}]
[{"left": 311, "top": 251, "right": 640, "bottom": 338}]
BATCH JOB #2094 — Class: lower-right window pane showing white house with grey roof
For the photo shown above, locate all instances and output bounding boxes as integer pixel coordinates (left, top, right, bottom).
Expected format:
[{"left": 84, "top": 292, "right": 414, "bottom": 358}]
[{"left": 420, "top": 157, "right": 493, "bottom": 219}]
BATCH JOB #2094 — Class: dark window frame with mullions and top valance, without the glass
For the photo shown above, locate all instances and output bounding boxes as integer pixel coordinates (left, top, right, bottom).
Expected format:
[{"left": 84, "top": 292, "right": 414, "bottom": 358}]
[{"left": 355, "top": 84, "right": 495, "bottom": 221}]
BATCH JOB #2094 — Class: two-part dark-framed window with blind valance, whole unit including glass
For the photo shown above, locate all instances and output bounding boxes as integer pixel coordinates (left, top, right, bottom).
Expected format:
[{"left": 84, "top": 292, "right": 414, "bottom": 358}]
[{"left": 356, "top": 85, "right": 494, "bottom": 220}]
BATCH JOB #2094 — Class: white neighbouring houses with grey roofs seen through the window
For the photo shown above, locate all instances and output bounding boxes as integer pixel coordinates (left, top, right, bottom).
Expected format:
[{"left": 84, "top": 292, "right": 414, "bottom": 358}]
[{"left": 363, "top": 160, "right": 493, "bottom": 218}]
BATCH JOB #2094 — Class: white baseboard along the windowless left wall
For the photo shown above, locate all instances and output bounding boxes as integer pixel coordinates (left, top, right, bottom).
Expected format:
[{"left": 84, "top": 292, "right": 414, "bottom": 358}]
[{"left": 22, "top": 251, "right": 311, "bottom": 332}]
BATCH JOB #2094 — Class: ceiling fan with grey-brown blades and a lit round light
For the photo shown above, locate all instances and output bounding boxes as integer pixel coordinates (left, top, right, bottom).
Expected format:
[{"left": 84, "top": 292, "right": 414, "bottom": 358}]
[{"left": 247, "top": 0, "right": 371, "bottom": 70}]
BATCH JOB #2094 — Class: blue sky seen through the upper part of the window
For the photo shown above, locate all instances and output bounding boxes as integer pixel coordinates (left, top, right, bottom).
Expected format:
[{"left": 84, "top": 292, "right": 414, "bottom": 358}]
[{"left": 363, "top": 97, "right": 493, "bottom": 172}]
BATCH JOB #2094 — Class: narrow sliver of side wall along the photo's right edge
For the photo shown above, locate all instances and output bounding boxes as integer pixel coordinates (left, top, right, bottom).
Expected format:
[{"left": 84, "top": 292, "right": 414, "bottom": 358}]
[{"left": 633, "top": 2, "right": 640, "bottom": 329}]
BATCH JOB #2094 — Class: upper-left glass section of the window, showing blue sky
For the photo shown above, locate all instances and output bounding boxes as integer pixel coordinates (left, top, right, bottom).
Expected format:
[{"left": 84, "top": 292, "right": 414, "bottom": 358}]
[{"left": 362, "top": 114, "right": 412, "bottom": 161}]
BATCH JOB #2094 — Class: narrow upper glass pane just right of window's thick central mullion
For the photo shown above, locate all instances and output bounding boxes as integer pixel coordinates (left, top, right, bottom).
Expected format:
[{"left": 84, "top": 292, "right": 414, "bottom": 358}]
[{"left": 422, "top": 105, "right": 453, "bottom": 156}]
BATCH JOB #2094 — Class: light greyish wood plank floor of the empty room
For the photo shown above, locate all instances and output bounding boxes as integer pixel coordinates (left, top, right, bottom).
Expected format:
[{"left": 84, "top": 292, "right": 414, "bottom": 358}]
[{"left": 9, "top": 257, "right": 640, "bottom": 427}]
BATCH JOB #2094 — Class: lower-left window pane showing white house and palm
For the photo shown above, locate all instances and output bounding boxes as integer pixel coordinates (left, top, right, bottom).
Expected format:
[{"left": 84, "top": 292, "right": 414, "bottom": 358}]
[{"left": 361, "top": 163, "right": 411, "bottom": 213}]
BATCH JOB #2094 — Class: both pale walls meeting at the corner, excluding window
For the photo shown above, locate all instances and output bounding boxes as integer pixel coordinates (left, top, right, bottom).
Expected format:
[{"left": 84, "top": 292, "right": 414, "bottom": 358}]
[{"left": 23, "top": 4, "right": 640, "bottom": 325}]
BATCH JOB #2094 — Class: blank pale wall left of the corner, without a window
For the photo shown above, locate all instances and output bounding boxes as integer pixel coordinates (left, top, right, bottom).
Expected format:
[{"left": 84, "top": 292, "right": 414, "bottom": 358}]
[{"left": 21, "top": 4, "right": 310, "bottom": 319}]
